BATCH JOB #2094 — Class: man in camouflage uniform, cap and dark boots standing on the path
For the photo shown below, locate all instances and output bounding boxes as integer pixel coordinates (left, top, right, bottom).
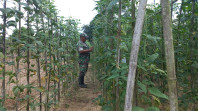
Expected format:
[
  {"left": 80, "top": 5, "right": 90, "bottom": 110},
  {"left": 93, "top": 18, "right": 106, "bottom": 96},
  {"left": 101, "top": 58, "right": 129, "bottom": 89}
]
[{"left": 77, "top": 33, "right": 93, "bottom": 88}]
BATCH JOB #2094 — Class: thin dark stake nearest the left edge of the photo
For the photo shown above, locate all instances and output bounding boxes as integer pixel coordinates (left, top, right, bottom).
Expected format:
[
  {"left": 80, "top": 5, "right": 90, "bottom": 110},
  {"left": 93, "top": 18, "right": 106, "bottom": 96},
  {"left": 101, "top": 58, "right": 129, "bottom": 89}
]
[{"left": 2, "top": 0, "right": 7, "bottom": 105}]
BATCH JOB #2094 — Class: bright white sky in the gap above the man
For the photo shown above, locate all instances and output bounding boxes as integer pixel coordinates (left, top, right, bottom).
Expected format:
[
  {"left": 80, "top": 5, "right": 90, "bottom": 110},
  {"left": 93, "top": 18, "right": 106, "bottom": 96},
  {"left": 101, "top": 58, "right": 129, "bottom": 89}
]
[{"left": 54, "top": 0, "right": 97, "bottom": 27}]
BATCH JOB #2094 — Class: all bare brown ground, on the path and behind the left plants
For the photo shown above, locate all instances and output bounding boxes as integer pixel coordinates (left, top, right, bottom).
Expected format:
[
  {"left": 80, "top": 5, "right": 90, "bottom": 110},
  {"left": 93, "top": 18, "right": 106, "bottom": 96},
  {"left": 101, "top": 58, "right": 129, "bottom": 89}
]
[{"left": 0, "top": 58, "right": 101, "bottom": 111}]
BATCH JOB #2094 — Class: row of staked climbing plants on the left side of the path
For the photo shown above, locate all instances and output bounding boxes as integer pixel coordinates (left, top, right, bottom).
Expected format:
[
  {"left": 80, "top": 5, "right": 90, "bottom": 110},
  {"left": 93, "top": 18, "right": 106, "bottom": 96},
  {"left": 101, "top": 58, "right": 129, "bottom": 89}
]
[{"left": 0, "top": 0, "right": 79, "bottom": 111}]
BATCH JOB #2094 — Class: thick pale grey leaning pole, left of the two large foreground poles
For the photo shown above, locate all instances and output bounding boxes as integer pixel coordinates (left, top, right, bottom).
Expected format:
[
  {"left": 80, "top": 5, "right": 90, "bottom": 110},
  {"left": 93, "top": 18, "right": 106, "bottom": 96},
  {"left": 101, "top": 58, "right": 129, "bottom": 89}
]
[{"left": 124, "top": 0, "right": 147, "bottom": 111}]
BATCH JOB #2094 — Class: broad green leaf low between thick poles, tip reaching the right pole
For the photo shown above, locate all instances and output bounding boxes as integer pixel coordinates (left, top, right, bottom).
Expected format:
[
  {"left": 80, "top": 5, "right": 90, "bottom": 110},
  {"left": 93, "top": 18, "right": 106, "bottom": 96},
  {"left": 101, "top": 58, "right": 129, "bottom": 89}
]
[{"left": 148, "top": 87, "right": 168, "bottom": 100}]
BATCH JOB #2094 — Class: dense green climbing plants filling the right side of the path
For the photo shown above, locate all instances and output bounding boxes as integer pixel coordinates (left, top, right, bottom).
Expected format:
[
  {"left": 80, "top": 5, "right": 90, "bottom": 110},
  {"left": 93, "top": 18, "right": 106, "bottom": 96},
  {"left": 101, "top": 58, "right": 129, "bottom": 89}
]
[{"left": 84, "top": 0, "right": 198, "bottom": 111}]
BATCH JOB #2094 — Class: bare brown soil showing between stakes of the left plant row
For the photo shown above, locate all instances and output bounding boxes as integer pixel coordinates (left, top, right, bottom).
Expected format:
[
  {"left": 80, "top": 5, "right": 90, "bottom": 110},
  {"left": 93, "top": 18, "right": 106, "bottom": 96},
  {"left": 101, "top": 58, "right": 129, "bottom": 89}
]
[{"left": 0, "top": 57, "right": 45, "bottom": 111}]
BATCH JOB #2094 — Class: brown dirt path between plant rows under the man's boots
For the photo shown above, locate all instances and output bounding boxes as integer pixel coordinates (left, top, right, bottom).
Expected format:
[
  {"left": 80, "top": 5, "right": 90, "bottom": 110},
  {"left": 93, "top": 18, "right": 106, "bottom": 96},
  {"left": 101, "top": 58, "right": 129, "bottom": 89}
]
[{"left": 57, "top": 66, "right": 101, "bottom": 111}]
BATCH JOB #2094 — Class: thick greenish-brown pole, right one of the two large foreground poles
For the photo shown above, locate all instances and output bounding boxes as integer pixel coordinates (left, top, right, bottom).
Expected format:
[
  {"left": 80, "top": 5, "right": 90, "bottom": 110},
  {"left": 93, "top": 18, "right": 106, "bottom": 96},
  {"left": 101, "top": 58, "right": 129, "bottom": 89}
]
[{"left": 161, "top": 0, "right": 178, "bottom": 111}]
